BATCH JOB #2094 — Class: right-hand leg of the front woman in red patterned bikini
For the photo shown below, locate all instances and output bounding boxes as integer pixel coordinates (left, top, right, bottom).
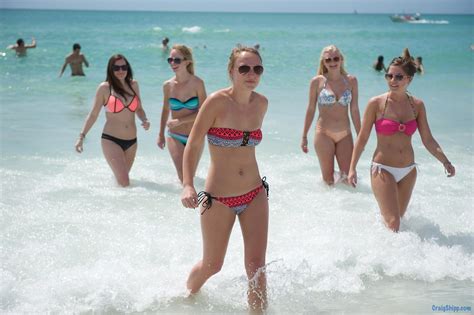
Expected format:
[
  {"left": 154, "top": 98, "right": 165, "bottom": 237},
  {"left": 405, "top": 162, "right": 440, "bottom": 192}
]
[{"left": 239, "top": 190, "right": 268, "bottom": 310}]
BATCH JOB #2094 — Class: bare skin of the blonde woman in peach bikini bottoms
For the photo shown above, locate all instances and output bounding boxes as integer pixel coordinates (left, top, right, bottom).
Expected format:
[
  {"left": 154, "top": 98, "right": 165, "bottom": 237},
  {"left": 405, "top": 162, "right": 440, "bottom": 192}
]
[{"left": 301, "top": 51, "right": 360, "bottom": 185}]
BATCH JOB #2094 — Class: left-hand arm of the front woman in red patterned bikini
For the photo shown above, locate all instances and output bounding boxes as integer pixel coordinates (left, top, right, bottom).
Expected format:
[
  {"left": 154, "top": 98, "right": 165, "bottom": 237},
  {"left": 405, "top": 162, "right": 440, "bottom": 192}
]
[{"left": 181, "top": 92, "right": 222, "bottom": 208}]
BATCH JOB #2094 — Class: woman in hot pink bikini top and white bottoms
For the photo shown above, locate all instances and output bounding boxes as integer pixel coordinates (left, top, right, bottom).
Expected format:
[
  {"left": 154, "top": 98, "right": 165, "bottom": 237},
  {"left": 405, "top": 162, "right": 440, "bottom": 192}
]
[{"left": 348, "top": 48, "right": 456, "bottom": 232}]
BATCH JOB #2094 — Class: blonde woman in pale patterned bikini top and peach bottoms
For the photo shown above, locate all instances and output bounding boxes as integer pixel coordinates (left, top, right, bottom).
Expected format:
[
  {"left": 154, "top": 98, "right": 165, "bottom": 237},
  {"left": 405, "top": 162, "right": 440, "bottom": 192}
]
[{"left": 301, "top": 45, "right": 360, "bottom": 185}]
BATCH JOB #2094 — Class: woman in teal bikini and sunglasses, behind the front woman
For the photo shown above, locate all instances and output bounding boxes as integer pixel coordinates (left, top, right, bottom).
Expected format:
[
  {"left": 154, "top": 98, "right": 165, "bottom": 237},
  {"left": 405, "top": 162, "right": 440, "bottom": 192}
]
[{"left": 157, "top": 45, "right": 206, "bottom": 182}]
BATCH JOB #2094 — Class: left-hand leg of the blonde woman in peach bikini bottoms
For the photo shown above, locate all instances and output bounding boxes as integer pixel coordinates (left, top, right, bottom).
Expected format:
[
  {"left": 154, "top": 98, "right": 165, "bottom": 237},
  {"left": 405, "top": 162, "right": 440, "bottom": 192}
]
[{"left": 314, "top": 132, "right": 336, "bottom": 185}]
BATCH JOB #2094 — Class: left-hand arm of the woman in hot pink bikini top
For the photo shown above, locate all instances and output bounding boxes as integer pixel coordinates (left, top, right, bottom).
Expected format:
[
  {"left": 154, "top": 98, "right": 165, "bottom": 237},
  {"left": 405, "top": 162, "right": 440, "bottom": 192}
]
[{"left": 348, "top": 97, "right": 379, "bottom": 187}]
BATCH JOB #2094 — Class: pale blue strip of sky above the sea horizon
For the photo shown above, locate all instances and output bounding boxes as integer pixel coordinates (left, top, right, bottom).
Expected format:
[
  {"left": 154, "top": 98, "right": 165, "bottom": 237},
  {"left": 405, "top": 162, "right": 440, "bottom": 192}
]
[{"left": 0, "top": 0, "right": 474, "bottom": 14}]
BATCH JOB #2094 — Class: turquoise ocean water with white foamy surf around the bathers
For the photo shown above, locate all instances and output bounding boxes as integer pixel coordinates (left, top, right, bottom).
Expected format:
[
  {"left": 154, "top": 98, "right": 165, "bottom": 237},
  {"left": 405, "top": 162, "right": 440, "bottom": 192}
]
[{"left": 0, "top": 10, "right": 474, "bottom": 314}]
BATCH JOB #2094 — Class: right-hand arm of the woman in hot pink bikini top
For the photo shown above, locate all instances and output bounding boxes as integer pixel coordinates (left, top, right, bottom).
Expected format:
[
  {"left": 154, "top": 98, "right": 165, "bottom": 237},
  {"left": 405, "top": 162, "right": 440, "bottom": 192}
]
[{"left": 415, "top": 100, "right": 456, "bottom": 177}]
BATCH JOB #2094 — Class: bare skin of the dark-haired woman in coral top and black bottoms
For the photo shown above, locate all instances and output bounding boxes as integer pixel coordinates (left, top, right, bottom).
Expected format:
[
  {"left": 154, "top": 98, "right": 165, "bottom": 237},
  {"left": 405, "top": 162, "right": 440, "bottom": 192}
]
[{"left": 75, "top": 59, "right": 150, "bottom": 187}]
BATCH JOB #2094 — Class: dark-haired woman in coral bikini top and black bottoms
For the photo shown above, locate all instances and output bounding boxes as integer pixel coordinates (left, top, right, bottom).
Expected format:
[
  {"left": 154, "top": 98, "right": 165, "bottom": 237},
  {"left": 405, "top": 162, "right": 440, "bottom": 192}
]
[{"left": 75, "top": 54, "right": 150, "bottom": 187}]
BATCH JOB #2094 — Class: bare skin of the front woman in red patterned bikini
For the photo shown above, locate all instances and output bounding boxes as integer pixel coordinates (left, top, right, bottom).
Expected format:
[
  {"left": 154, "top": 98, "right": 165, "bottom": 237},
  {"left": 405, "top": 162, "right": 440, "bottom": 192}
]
[{"left": 181, "top": 52, "right": 268, "bottom": 310}]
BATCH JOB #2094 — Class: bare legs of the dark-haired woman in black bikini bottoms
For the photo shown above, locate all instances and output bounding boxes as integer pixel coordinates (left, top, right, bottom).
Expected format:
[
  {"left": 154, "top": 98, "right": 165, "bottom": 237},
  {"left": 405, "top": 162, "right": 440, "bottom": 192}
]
[{"left": 101, "top": 139, "right": 137, "bottom": 187}]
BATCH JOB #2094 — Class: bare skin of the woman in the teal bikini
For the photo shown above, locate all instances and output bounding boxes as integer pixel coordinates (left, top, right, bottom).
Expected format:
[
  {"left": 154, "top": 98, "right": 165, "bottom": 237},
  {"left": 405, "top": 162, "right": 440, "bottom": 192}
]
[{"left": 157, "top": 49, "right": 206, "bottom": 182}]
